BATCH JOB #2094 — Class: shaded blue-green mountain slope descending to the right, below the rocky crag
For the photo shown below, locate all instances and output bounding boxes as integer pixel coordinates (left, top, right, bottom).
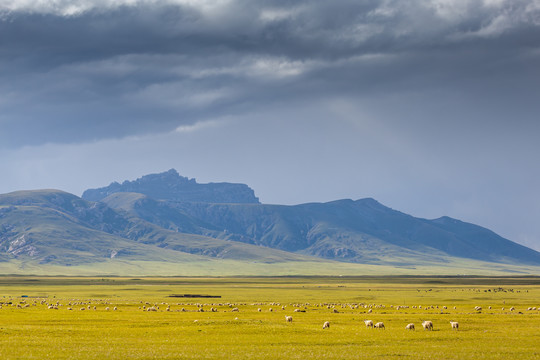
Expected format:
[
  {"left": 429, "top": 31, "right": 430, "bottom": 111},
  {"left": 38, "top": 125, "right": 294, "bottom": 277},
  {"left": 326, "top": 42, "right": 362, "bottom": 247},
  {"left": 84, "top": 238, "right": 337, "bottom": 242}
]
[{"left": 104, "top": 198, "right": 540, "bottom": 265}]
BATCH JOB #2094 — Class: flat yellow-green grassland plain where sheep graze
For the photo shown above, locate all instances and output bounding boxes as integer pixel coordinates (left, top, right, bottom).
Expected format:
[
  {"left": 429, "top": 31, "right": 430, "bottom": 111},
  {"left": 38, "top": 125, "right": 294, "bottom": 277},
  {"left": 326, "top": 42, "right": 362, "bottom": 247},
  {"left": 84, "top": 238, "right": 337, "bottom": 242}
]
[{"left": 0, "top": 277, "right": 540, "bottom": 359}]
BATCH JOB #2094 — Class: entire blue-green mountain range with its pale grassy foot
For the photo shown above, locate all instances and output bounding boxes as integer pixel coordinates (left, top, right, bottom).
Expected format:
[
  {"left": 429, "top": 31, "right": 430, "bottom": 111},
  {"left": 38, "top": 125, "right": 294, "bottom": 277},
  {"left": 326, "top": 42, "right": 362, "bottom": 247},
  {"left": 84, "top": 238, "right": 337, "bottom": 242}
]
[{"left": 0, "top": 169, "right": 540, "bottom": 275}]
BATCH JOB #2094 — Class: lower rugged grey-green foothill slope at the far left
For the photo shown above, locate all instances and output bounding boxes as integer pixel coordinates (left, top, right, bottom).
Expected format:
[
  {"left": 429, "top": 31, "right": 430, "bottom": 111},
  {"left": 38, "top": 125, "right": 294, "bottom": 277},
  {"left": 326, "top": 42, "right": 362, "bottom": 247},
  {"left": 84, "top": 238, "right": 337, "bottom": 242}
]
[{"left": 0, "top": 198, "right": 193, "bottom": 266}]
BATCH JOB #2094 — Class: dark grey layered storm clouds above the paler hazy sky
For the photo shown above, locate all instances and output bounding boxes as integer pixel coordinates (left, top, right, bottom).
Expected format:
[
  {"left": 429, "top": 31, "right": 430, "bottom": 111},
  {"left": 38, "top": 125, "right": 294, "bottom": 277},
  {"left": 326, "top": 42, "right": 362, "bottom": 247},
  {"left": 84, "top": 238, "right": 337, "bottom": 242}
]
[{"left": 0, "top": 0, "right": 540, "bottom": 147}]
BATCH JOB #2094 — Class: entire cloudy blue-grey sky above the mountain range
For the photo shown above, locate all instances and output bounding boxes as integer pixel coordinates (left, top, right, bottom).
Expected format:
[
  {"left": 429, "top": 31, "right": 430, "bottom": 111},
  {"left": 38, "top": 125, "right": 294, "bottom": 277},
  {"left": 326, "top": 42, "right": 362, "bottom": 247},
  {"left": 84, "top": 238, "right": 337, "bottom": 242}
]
[{"left": 0, "top": 0, "right": 540, "bottom": 250}]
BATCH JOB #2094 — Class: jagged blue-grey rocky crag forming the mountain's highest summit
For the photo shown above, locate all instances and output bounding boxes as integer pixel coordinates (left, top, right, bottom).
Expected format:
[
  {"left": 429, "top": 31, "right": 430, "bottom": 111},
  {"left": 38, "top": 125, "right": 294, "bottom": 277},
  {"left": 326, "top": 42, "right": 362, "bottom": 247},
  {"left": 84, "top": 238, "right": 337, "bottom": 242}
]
[{"left": 82, "top": 169, "right": 259, "bottom": 204}]
